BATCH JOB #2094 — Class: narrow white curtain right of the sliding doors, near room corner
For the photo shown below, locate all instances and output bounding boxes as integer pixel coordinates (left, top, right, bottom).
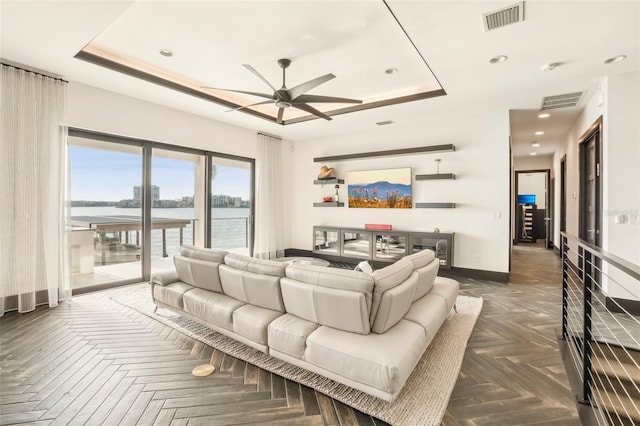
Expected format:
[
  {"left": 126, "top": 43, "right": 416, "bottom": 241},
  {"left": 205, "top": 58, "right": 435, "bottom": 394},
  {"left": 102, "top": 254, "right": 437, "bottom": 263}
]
[{"left": 253, "top": 133, "right": 284, "bottom": 259}]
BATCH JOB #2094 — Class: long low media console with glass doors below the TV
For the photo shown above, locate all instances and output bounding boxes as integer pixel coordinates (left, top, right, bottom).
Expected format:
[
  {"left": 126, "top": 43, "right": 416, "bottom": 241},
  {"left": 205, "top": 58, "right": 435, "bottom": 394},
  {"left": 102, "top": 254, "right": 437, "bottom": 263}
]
[{"left": 312, "top": 226, "right": 454, "bottom": 269}]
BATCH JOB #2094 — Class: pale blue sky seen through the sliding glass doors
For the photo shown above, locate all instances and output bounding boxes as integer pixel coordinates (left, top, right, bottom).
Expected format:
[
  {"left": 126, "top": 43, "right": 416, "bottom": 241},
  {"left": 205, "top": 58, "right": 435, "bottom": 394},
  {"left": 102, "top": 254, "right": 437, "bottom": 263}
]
[{"left": 69, "top": 145, "right": 250, "bottom": 201}]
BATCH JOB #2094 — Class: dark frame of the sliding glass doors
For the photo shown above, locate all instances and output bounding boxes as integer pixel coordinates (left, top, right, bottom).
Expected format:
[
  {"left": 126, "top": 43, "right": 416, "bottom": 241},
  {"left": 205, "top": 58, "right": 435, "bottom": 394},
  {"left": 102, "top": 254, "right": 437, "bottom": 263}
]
[{"left": 68, "top": 127, "right": 255, "bottom": 294}]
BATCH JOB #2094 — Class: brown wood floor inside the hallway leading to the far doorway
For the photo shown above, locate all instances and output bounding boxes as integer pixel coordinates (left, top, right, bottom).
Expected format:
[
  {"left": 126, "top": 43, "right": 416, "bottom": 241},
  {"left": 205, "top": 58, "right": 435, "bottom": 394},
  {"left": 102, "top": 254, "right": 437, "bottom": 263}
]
[{"left": 509, "top": 240, "right": 562, "bottom": 285}]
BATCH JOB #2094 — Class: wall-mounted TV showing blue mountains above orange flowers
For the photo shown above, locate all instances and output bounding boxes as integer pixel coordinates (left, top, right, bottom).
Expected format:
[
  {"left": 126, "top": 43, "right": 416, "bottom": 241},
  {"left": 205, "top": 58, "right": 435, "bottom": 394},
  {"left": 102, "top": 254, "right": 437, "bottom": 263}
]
[{"left": 347, "top": 167, "right": 412, "bottom": 209}]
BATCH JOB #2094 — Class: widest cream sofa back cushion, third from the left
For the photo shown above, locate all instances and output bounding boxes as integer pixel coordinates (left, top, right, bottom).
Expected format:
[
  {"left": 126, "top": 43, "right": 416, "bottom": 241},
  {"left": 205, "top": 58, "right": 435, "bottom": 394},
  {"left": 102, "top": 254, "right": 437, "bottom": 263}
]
[{"left": 280, "top": 264, "right": 373, "bottom": 334}]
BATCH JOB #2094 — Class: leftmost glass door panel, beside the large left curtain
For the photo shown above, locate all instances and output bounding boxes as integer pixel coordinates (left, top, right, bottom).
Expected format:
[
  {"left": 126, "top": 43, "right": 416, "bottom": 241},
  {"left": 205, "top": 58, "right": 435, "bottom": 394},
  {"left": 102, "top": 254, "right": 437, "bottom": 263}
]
[{"left": 68, "top": 136, "right": 143, "bottom": 289}]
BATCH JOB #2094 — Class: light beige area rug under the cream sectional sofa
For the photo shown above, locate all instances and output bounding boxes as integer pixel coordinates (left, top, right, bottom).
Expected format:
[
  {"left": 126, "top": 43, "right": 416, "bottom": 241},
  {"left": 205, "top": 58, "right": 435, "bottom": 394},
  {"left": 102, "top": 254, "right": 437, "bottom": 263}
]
[{"left": 112, "top": 284, "right": 482, "bottom": 425}]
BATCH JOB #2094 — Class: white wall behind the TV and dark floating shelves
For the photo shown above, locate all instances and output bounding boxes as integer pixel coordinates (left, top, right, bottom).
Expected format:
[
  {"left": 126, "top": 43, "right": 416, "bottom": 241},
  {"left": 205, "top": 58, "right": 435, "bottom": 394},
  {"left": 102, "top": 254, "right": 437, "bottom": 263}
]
[{"left": 291, "top": 110, "right": 509, "bottom": 272}]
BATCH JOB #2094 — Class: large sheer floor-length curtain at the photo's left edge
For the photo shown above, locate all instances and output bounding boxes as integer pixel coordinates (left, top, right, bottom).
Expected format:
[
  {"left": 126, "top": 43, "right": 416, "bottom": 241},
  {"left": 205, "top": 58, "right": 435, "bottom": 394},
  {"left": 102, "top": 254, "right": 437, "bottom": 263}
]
[{"left": 0, "top": 64, "right": 70, "bottom": 316}]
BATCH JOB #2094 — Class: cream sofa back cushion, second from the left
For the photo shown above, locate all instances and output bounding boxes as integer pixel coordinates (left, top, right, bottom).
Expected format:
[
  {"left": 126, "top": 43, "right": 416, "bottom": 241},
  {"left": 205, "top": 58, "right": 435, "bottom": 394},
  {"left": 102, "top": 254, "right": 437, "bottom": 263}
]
[{"left": 220, "top": 253, "right": 286, "bottom": 312}]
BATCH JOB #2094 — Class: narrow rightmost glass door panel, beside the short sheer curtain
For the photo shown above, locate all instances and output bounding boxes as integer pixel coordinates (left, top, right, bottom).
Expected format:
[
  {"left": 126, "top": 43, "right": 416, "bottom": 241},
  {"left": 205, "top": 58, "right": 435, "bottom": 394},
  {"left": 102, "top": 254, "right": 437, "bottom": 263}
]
[{"left": 209, "top": 156, "right": 254, "bottom": 256}]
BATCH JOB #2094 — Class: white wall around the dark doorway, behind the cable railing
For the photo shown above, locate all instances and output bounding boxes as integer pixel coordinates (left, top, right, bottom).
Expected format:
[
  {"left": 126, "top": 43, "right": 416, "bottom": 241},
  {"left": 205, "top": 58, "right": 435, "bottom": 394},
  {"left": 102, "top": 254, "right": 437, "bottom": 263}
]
[{"left": 554, "top": 72, "right": 640, "bottom": 300}]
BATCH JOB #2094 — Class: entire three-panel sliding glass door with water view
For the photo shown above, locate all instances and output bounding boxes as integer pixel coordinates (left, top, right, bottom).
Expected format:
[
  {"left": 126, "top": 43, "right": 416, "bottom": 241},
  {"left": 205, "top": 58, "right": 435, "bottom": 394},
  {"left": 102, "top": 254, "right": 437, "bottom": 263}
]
[{"left": 68, "top": 128, "right": 254, "bottom": 292}]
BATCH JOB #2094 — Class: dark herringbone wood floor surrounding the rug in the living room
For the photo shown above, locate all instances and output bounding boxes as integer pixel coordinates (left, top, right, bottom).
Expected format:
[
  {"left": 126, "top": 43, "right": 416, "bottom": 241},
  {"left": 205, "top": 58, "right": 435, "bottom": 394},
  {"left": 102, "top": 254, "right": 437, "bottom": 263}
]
[{"left": 0, "top": 246, "right": 579, "bottom": 425}]
